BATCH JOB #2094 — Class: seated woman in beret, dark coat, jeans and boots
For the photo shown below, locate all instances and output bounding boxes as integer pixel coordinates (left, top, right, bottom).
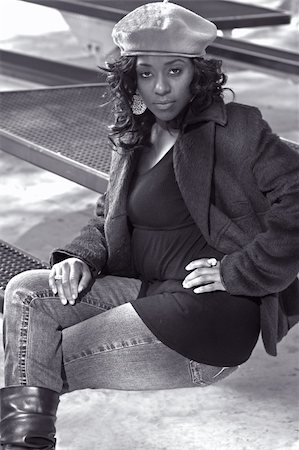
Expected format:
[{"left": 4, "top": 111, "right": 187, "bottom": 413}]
[{"left": 1, "top": 2, "right": 299, "bottom": 449}]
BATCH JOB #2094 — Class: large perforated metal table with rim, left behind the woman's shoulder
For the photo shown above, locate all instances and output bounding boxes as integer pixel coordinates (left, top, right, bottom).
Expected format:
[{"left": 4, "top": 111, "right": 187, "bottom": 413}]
[{"left": 0, "top": 84, "right": 112, "bottom": 192}]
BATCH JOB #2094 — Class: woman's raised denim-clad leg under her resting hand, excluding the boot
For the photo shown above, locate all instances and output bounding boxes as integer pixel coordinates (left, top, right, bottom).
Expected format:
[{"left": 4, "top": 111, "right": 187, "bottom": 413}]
[{"left": 4, "top": 270, "right": 141, "bottom": 393}]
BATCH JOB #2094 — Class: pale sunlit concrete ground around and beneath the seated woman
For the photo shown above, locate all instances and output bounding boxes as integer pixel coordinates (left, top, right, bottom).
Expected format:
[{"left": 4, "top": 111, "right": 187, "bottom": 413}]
[{"left": 0, "top": 2, "right": 299, "bottom": 450}]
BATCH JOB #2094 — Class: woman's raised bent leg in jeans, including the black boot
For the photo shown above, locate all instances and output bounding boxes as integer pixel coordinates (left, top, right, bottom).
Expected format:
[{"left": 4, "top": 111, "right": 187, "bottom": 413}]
[{"left": 0, "top": 271, "right": 140, "bottom": 450}]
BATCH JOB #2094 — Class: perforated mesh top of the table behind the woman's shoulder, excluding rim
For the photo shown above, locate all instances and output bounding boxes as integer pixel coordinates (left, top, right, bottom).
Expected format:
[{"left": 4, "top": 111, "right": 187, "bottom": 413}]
[{"left": 0, "top": 85, "right": 112, "bottom": 173}]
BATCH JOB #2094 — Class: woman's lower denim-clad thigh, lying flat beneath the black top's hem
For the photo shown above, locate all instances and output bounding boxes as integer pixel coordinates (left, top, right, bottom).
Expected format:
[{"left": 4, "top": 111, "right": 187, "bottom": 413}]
[{"left": 62, "top": 303, "right": 236, "bottom": 391}]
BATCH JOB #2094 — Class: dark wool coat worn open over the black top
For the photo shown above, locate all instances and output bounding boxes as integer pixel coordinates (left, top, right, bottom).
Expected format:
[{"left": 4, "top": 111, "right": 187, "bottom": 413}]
[{"left": 52, "top": 101, "right": 299, "bottom": 355}]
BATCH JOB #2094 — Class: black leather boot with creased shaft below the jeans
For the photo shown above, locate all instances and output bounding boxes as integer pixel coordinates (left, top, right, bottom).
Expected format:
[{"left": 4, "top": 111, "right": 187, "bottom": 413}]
[{"left": 0, "top": 386, "right": 59, "bottom": 450}]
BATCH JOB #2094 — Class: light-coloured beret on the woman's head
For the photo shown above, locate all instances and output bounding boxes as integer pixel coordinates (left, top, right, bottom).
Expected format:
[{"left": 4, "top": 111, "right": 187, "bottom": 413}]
[{"left": 112, "top": 0, "right": 217, "bottom": 58}]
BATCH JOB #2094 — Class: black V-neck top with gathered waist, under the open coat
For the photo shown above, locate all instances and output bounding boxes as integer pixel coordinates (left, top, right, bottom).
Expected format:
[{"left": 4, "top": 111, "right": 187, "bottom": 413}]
[{"left": 128, "top": 150, "right": 260, "bottom": 366}]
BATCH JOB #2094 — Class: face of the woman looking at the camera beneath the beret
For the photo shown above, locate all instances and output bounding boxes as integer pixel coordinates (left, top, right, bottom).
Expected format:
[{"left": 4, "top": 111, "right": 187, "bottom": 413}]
[{"left": 136, "top": 55, "right": 194, "bottom": 122}]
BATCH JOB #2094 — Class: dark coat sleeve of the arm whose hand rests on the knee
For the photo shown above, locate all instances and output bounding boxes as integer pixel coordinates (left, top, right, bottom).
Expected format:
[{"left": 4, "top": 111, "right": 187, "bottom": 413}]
[{"left": 50, "top": 193, "right": 107, "bottom": 277}]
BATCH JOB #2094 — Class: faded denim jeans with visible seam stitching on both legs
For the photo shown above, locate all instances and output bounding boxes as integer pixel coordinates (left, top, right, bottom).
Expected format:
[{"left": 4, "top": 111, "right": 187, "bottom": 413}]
[{"left": 4, "top": 270, "right": 236, "bottom": 393}]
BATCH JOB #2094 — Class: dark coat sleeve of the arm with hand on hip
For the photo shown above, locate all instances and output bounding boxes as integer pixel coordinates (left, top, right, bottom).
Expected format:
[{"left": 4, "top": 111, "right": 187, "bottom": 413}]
[{"left": 221, "top": 111, "right": 299, "bottom": 297}]
